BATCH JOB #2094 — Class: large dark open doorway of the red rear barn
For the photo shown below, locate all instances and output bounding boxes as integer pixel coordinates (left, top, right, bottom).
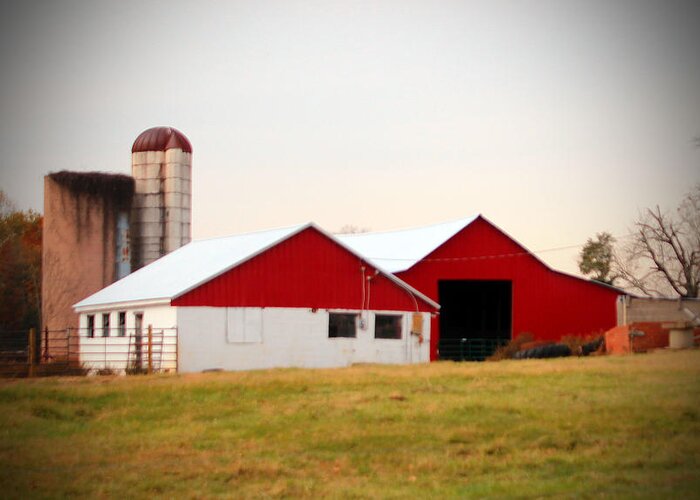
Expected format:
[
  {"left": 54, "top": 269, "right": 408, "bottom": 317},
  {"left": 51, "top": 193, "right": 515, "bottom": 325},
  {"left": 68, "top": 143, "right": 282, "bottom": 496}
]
[{"left": 438, "top": 280, "right": 513, "bottom": 361}]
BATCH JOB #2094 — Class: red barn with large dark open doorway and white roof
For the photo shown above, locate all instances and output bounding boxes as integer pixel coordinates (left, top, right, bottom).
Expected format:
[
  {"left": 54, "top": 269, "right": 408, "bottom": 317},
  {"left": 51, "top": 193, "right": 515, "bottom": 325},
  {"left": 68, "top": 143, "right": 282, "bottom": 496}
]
[{"left": 341, "top": 215, "right": 624, "bottom": 360}]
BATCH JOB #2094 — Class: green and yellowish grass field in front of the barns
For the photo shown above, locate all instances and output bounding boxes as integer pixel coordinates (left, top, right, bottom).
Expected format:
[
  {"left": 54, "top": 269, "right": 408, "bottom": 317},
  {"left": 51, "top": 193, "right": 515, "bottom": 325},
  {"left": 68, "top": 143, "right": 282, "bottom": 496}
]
[{"left": 0, "top": 350, "right": 700, "bottom": 498}]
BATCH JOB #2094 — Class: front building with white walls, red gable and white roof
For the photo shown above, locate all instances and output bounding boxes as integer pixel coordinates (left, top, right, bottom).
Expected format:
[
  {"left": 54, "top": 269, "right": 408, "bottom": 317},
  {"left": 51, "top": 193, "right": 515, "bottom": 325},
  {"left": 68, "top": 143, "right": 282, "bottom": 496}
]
[{"left": 74, "top": 224, "right": 439, "bottom": 372}]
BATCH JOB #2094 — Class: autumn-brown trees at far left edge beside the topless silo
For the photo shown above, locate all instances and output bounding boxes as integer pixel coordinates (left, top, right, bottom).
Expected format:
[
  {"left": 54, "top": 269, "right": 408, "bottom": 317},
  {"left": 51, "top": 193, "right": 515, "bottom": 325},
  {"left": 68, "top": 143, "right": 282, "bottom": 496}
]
[{"left": 0, "top": 191, "right": 42, "bottom": 331}]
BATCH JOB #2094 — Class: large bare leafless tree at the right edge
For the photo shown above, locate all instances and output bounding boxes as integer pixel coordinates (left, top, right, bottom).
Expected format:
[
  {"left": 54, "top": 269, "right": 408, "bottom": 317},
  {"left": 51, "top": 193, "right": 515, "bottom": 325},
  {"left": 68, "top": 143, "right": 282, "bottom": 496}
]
[{"left": 615, "top": 184, "right": 700, "bottom": 298}]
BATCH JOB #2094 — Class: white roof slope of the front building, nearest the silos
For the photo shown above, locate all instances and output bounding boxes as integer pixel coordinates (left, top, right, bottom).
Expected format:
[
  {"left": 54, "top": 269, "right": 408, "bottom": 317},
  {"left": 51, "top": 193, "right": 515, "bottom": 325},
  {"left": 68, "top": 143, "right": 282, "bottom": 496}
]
[{"left": 73, "top": 224, "right": 310, "bottom": 308}]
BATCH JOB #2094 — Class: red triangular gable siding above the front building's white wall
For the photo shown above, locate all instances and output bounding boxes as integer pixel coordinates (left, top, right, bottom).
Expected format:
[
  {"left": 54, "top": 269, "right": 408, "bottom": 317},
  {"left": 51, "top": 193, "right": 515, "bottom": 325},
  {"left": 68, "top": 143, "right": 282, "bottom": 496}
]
[{"left": 172, "top": 228, "right": 433, "bottom": 312}]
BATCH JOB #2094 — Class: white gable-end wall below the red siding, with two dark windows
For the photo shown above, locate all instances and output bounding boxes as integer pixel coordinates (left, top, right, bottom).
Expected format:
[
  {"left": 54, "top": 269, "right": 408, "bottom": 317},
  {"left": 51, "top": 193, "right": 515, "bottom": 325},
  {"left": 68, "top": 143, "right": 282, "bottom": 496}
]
[{"left": 177, "top": 307, "right": 430, "bottom": 372}]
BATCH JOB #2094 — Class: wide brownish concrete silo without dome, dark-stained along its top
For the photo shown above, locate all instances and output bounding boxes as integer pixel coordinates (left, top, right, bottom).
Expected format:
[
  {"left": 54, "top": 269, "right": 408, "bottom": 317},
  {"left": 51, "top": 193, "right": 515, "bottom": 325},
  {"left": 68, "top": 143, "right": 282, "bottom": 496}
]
[{"left": 41, "top": 171, "right": 134, "bottom": 340}]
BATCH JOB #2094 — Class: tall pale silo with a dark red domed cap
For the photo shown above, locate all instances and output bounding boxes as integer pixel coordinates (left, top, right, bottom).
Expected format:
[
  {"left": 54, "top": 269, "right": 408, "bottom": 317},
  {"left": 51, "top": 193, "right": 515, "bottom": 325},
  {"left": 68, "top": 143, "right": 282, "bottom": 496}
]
[{"left": 131, "top": 127, "right": 192, "bottom": 270}]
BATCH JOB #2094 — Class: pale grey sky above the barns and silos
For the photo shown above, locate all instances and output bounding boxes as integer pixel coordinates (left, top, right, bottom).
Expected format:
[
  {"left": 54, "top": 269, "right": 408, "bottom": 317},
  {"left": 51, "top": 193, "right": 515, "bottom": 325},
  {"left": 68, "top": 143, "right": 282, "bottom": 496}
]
[{"left": 0, "top": 0, "right": 700, "bottom": 271}]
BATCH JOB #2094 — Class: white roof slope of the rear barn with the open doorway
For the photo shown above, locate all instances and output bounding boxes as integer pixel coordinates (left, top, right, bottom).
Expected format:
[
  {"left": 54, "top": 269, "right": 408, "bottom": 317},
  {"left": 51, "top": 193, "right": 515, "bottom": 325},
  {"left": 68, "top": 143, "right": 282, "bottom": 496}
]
[{"left": 337, "top": 216, "right": 476, "bottom": 273}]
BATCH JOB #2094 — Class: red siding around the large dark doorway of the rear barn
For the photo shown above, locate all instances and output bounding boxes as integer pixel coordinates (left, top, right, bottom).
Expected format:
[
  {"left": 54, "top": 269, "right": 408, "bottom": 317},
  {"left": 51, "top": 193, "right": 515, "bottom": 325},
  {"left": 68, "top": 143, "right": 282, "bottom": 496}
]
[{"left": 397, "top": 217, "right": 619, "bottom": 360}]
